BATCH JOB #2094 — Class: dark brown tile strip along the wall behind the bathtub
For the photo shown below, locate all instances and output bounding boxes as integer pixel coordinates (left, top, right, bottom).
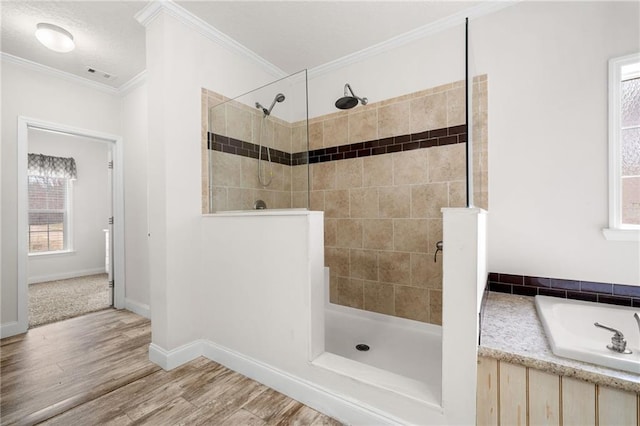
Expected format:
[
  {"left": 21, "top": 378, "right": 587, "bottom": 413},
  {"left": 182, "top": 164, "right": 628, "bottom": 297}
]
[{"left": 487, "top": 272, "right": 640, "bottom": 308}]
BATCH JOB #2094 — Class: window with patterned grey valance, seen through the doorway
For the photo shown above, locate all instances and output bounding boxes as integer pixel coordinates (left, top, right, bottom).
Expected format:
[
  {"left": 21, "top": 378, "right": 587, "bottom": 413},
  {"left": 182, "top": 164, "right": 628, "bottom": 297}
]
[{"left": 28, "top": 154, "right": 77, "bottom": 253}]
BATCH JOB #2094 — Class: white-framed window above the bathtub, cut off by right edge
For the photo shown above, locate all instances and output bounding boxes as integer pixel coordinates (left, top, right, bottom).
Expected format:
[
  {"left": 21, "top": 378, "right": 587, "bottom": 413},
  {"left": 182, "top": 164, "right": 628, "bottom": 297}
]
[{"left": 604, "top": 53, "right": 640, "bottom": 241}]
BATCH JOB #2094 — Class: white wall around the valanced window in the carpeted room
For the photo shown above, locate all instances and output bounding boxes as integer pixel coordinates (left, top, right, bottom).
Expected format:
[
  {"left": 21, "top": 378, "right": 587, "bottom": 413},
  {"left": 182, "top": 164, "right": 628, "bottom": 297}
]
[{"left": 28, "top": 129, "right": 111, "bottom": 283}]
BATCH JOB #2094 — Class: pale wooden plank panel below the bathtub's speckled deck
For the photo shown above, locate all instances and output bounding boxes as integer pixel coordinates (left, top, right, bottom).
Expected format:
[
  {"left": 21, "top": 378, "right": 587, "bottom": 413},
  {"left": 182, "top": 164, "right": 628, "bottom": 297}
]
[{"left": 476, "top": 357, "right": 640, "bottom": 426}]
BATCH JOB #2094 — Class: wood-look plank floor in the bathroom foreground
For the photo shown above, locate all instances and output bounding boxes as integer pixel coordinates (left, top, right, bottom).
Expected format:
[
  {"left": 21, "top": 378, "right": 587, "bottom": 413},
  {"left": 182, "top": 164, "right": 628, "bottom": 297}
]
[{"left": 0, "top": 309, "right": 340, "bottom": 426}]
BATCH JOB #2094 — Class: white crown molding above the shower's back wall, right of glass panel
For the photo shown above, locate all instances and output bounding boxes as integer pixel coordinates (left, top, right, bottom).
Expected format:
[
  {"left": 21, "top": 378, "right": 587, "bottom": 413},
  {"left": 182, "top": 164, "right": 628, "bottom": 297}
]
[{"left": 309, "top": 0, "right": 522, "bottom": 79}]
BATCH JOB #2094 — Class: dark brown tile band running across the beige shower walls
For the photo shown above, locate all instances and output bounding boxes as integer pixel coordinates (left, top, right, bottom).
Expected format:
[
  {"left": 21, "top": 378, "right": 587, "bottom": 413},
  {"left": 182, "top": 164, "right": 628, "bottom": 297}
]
[{"left": 207, "top": 124, "right": 467, "bottom": 166}]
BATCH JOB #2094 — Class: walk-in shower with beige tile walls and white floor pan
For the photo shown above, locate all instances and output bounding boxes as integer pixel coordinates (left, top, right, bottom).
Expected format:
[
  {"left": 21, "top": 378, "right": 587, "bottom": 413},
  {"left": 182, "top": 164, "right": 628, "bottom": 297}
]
[{"left": 203, "top": 18, "right": 487, "bottom": 414}]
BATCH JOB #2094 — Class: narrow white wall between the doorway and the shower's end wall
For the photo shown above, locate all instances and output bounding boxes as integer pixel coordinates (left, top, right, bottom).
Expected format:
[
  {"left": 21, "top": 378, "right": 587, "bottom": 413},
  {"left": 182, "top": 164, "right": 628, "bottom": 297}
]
[{"left": 121, "top": 84, "right": 150, "bottom": 317}]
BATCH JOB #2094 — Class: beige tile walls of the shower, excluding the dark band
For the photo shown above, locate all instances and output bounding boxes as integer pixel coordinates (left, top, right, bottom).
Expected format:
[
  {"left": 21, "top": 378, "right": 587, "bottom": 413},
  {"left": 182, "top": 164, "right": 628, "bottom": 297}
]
[{"left": 202, "top": 76, "right": 487, "bottom": 324}]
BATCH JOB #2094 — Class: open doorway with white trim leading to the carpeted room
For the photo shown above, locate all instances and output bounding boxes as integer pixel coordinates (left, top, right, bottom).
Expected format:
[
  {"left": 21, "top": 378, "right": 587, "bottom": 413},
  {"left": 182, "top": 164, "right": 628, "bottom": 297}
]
[{"left": 18, "top": 117, "right": 124, "bottom": 331}]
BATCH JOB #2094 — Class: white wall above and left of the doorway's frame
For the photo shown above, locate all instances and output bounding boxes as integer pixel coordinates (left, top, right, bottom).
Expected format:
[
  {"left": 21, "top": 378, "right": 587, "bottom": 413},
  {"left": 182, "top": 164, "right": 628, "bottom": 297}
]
[{"left": 0, "top": 60, "right": 120, "bottom": 325}]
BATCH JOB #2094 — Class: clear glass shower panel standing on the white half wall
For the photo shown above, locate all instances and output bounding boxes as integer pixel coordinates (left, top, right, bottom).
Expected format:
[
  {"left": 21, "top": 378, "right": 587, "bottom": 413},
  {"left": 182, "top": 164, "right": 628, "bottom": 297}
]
[{"left": 205, "top": 70, "right": 309, "bottom": 213}]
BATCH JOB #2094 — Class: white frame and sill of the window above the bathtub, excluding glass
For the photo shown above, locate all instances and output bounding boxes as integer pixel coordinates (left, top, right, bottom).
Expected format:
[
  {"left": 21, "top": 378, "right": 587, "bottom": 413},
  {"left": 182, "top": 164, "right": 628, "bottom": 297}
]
[{"left": 602, "top": 52, "right": 640, "bottom": 241}]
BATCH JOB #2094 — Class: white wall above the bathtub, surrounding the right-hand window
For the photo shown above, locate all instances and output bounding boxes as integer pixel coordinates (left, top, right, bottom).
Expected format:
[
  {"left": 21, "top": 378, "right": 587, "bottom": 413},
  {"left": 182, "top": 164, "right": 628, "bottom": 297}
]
[{"left": 470, "top": 2, "right": 640, "bottom": 285}]
